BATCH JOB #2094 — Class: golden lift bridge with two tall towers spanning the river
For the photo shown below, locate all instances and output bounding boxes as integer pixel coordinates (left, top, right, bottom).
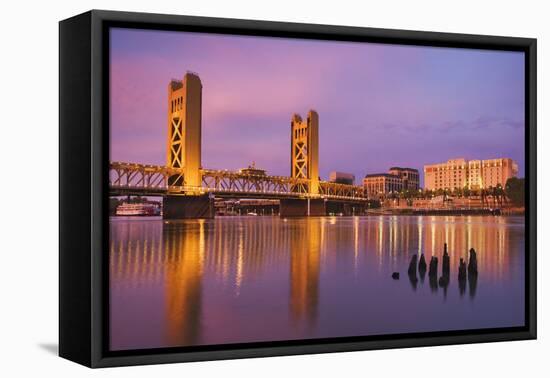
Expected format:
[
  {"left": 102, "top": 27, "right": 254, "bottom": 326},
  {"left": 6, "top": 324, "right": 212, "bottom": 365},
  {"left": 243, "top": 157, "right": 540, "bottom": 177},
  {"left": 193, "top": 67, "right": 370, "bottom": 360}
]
[{"left": 109, "top": 72, "right": 368, "bottom": 218}]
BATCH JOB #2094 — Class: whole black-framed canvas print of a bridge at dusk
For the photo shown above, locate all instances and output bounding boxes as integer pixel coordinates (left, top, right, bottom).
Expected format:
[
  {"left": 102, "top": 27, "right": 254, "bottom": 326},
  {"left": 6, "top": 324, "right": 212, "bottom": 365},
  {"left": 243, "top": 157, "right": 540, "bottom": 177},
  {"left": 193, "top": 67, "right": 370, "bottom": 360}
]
[{"left": 59, "top": 10, "right": 536, "bottom": 367}]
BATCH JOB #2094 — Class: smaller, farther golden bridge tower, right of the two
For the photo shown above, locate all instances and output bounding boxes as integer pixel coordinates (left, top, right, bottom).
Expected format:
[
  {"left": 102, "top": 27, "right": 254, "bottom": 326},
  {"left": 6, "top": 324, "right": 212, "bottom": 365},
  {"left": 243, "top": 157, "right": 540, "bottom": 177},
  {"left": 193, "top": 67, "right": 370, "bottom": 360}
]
[{"left": 290, "top": 110, "right": 319, "bottom": 194}]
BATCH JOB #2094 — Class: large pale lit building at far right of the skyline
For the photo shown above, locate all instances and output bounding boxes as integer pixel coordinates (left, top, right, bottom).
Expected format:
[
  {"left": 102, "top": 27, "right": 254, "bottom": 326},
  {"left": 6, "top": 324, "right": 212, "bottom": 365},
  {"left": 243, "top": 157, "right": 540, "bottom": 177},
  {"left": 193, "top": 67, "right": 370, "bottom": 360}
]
[{"left": 424, "top": 158, "right": 518, "bottom": 190}]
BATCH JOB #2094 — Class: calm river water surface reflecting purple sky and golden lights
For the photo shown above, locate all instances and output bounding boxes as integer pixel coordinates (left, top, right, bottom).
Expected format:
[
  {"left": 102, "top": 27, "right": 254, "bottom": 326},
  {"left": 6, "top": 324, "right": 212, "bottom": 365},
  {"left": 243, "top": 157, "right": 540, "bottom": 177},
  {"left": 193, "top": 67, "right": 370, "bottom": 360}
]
[{"left": 109, "top": 216, "right": 525, "bottom": 350}]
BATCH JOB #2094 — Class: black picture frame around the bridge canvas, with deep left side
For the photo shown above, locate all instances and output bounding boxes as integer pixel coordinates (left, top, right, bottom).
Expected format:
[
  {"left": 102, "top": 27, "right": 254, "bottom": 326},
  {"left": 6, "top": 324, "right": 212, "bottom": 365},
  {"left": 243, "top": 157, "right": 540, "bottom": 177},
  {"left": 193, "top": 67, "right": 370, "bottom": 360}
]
[{"left": 59, "top": 10, "right": 537, "bottom": 367}]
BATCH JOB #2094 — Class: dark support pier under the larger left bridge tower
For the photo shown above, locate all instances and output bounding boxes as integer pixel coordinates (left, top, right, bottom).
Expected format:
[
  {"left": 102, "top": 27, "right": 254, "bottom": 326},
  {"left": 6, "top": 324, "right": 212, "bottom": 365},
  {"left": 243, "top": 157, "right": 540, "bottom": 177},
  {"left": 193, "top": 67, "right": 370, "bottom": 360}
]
[{"left": 162, "top": 194, "right": 215, "bottom": 219}]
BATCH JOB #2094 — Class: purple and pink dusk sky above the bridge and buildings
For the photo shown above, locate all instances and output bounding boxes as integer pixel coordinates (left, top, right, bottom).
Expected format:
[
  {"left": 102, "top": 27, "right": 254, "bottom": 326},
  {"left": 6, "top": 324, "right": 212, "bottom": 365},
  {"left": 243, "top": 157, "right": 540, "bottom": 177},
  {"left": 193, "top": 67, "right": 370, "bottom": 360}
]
[{"left": 110, "top": 29, "right": 524, "bottom": 185}]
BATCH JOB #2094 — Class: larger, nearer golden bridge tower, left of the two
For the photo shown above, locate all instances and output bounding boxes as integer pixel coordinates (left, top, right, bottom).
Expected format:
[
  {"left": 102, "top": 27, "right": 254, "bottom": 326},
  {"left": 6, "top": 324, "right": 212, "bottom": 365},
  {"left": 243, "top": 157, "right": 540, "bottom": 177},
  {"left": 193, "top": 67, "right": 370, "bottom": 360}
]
[{"left": 166, "top": 72, "right": 202, "bottom": 187}]
